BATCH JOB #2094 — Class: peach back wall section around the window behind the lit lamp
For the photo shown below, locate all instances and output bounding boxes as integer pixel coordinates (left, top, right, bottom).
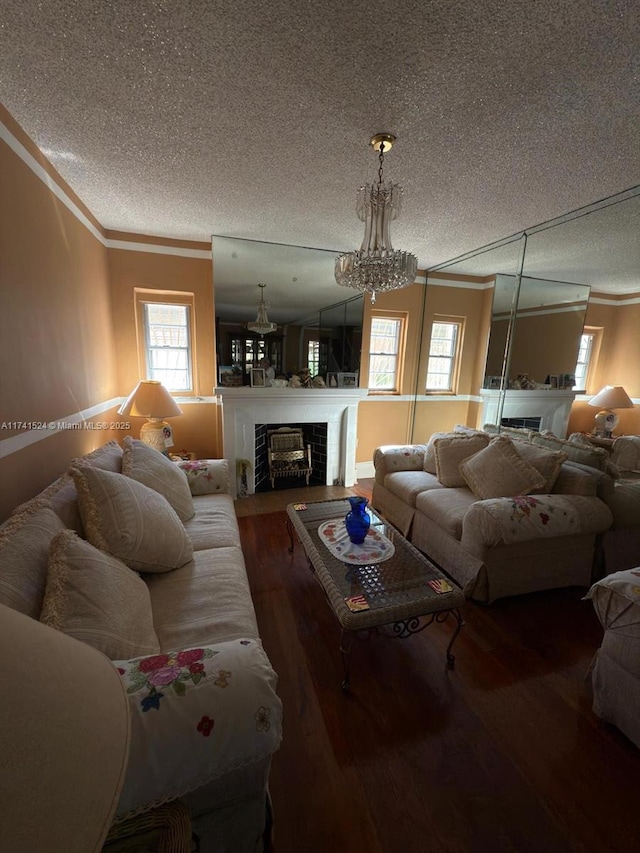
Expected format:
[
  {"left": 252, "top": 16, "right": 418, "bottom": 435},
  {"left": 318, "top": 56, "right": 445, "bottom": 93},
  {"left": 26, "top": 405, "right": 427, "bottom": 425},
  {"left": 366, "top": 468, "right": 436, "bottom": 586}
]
[{"left": 108, "top": 240, "right": 222, "bottom": 458}]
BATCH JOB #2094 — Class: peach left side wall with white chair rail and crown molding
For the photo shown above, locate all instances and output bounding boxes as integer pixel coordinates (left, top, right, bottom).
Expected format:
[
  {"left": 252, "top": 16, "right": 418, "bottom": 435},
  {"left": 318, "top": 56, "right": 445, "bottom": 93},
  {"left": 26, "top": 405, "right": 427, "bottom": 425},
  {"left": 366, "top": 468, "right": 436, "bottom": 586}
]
[{"left": 0, "top": 107, "right": 118, "bottom": 518}]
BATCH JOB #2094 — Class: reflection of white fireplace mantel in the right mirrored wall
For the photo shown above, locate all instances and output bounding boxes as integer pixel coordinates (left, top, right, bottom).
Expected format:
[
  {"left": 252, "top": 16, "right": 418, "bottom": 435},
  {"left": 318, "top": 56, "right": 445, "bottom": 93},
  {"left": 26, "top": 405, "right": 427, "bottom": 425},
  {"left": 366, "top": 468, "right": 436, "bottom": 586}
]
[{"left": 481, "top": 389, "right": 576, "bottom": 438}]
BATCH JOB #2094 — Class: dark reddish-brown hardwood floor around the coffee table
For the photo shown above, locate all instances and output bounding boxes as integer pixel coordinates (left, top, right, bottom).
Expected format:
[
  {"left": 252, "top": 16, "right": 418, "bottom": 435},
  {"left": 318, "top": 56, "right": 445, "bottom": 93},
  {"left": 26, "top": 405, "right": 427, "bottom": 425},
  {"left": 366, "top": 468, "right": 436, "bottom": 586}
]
[{"left": 238, "top": 481, "right": 640, "bottom": 853}]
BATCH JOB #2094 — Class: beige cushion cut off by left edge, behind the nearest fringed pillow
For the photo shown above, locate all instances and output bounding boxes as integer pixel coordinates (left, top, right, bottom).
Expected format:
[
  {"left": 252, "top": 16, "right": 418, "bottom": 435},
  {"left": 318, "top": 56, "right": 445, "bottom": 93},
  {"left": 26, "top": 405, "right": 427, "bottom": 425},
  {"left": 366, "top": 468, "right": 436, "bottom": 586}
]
[{"left": 0, "top": 503, "right": 64, "bottom": 619}]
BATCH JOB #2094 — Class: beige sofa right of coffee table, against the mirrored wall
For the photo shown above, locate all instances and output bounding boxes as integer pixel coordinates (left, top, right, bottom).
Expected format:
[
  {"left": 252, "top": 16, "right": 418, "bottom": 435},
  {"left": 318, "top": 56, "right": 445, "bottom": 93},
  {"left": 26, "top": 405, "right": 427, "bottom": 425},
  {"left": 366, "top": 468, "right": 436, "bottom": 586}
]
[{"left": 372, "top": 427, "right": 613, "bottom": 603}]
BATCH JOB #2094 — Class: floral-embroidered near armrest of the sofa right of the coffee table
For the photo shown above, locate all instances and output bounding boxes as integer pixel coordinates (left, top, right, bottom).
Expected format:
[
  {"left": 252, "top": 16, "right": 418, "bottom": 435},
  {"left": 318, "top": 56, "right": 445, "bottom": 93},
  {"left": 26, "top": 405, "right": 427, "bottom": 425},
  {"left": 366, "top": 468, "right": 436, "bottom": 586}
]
[{"left": 461, "top": 495, "right": 613, "bottom": 556}]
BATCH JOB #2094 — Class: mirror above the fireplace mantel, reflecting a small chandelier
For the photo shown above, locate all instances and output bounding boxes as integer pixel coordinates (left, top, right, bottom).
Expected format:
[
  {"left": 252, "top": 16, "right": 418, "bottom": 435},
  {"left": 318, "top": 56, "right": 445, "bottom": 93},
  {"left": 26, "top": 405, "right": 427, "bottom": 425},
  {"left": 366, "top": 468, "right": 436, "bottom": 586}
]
[{"left": 212, "top": 235, "right": 364, "bottom": 377}]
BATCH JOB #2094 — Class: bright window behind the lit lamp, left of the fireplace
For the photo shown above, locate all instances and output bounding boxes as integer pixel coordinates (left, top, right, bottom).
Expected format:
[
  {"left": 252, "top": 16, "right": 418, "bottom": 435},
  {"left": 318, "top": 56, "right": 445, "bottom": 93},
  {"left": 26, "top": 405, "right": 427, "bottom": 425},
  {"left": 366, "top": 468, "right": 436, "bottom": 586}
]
[{"left": 141, "top": 299, "right": 193, "bottom": 391}]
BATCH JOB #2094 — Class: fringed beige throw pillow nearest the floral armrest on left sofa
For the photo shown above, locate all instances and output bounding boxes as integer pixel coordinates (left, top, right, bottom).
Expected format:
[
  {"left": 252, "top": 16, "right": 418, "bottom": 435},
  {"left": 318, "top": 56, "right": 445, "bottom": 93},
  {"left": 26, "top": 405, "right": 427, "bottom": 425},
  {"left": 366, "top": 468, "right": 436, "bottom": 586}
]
[{"left": 40, "top": 530, "right": 160, "bottom": 660}]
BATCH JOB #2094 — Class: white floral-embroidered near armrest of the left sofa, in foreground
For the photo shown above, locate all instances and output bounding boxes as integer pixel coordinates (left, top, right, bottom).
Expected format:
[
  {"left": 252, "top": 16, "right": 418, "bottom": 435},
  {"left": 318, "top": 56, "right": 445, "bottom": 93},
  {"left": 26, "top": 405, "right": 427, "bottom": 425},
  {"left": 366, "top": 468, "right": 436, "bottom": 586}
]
[{"left": 113, "top": 639, "right": 282, "bottom": 820}]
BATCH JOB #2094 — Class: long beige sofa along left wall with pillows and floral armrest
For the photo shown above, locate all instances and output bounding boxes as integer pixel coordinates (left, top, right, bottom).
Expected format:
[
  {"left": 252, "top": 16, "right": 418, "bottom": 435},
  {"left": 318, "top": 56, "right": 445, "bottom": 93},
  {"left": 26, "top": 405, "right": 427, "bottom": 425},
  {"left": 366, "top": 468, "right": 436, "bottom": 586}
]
[{"left": 0, "top": 437, "right": 282, "bottom": 853}]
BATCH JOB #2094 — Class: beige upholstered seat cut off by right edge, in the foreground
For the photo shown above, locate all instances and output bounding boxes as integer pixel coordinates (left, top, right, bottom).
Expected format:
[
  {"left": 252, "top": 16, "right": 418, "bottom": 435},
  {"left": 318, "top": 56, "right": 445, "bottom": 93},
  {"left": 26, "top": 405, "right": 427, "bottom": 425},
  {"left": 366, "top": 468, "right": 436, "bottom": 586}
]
[{"left": 587, "top": 568, "right": 640, "bottom": 747}]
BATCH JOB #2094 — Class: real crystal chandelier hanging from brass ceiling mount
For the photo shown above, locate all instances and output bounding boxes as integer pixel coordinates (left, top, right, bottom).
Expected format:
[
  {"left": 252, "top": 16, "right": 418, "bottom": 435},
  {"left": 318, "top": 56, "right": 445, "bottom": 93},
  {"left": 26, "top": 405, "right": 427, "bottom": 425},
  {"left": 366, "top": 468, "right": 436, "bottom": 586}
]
[{"left": 336, "top": 133, "right": 418, "bottom": 303}]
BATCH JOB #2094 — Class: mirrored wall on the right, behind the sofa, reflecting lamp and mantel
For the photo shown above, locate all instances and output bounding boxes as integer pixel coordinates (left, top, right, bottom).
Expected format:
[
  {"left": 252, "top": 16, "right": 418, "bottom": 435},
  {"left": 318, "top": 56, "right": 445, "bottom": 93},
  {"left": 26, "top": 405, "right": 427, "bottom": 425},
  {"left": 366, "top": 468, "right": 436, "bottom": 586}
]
[{"left": 414, "top": 188, "right": 640, "bottom": 440}]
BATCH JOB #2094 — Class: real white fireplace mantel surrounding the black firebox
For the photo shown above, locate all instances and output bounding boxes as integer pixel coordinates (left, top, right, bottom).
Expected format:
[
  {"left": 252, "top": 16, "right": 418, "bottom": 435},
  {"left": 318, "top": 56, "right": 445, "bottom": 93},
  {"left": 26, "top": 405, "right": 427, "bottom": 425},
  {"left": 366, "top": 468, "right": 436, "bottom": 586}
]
[{"left": 215, "top": 386, "right": 367, "bottom": 498}]
